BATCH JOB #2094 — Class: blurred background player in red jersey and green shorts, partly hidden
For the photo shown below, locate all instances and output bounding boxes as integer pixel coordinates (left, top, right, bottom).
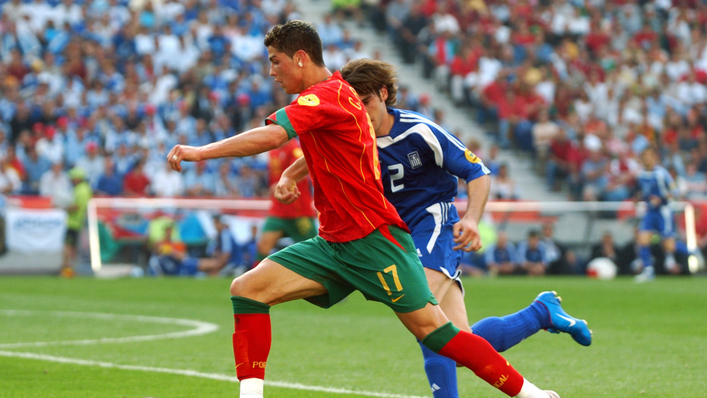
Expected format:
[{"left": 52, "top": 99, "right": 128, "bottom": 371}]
[{"left": 253, "top": 140, "right": 317, "bottom": 266}]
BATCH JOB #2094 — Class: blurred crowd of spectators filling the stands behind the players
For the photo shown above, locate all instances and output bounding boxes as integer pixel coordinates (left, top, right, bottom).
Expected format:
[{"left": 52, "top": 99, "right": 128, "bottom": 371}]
[{"left": 0, "top": 0, "right": 707, "bottom": 274}]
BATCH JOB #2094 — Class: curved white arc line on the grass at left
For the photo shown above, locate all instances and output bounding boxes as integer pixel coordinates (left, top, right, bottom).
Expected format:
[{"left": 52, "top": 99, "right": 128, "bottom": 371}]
[{"left": 0, "top": 310, "right": 218, "bottom": 348}]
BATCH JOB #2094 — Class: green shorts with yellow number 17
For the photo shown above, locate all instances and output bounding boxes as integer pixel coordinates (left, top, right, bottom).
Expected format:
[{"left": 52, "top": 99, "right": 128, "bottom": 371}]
[{"left": 268, "top": 226, "right": 437, "bottom": 313}]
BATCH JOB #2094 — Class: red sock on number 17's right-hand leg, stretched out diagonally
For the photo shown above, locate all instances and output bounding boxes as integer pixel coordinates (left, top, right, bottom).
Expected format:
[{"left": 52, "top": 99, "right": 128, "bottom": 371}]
[{"left": 439, "top": 331, "right": 523, "bottom": 397}]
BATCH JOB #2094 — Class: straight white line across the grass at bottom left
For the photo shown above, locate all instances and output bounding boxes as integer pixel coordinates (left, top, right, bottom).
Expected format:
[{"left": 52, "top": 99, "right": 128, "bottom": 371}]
[{"left": 0, "top": 351, "right": 425, "bottom": 398}]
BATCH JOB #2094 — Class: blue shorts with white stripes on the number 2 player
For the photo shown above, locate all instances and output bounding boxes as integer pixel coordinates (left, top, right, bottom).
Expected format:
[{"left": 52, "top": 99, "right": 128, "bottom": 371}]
[{"left": 411, "top": 203, "right": 464, "bottom": 291}]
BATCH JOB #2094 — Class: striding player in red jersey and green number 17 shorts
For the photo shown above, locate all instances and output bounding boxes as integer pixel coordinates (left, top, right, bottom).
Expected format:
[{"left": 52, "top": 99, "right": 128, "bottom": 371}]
[{"left": 168, "top": 21, "right": 558, "bottom": 398}]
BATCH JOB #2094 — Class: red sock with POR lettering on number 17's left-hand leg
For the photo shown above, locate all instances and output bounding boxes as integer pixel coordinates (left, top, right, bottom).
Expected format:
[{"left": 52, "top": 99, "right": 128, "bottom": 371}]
[{"left": 233, "top": 314, "right": 272, "bottom": 380}]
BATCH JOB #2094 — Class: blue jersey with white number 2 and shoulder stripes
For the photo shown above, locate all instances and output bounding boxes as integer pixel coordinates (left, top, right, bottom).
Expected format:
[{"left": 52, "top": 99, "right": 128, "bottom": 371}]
[{"left": 377, "top": 108, "right": 490, "bottom": 233}]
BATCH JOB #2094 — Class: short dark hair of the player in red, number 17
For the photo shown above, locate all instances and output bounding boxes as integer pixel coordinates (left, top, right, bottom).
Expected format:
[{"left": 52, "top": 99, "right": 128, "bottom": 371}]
[{"left": 263, "top": 20, "right": 324, "bottom": 66}]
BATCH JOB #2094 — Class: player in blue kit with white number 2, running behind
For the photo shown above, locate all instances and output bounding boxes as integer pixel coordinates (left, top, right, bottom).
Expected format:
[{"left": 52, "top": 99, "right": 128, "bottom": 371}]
[{"left": 275, "top": 59, "right": 591, "bottom": 398}]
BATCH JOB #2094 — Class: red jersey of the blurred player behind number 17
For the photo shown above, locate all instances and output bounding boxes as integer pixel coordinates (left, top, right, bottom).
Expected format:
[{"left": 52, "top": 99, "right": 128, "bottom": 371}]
[{"left": 269, "top": 140, "right": 317, "bottom": 218}]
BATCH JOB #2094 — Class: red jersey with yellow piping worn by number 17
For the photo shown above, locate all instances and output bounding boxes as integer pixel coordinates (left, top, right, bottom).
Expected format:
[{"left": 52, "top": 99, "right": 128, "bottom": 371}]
[{"left": 267, "top": 72, "right": 408, "bottom": 242}]
